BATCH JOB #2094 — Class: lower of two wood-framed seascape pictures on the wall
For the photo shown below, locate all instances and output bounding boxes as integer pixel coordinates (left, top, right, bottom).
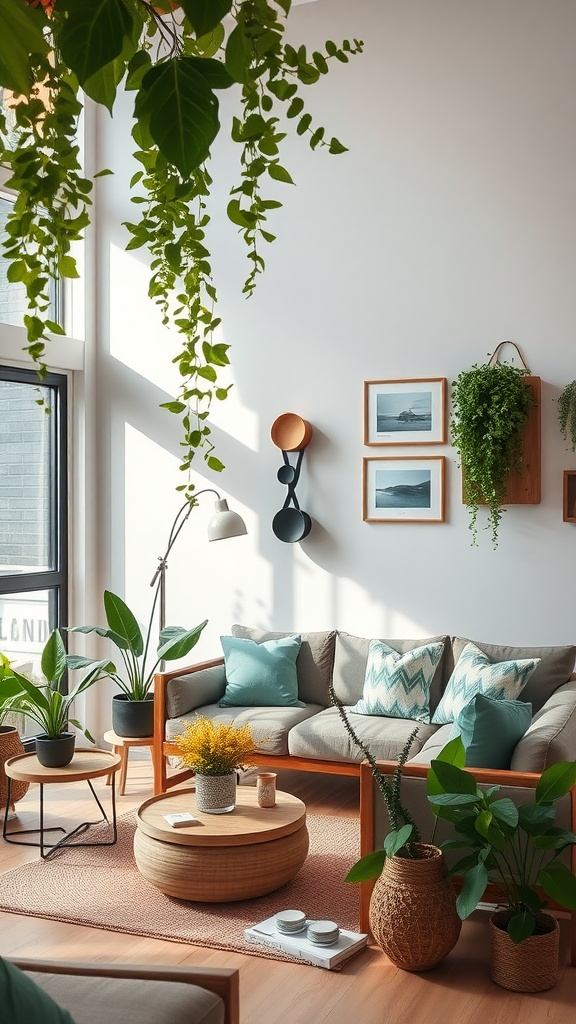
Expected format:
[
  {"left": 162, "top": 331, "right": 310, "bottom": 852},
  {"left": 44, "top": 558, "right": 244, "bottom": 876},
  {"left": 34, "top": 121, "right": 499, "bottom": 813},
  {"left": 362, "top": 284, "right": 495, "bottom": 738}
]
[{"left": 362, "top": 456, "right": 446, "bottom": 522}]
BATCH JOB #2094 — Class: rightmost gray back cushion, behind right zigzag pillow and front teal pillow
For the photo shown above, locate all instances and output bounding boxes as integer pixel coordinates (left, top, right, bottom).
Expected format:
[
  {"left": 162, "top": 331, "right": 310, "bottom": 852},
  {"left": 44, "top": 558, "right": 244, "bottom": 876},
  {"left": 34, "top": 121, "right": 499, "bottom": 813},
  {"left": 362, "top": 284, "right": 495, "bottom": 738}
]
[{"left": 452, "top": 637, "right": 576, "bottom": 714}]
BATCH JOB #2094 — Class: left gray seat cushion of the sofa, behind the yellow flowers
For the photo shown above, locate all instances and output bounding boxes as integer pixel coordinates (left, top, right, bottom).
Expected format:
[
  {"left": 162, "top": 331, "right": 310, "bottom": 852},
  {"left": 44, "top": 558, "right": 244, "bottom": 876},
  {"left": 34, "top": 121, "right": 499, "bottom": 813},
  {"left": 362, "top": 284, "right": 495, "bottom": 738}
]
[{"left": 166, "top": 705, "right": 324, "bottom": 755}]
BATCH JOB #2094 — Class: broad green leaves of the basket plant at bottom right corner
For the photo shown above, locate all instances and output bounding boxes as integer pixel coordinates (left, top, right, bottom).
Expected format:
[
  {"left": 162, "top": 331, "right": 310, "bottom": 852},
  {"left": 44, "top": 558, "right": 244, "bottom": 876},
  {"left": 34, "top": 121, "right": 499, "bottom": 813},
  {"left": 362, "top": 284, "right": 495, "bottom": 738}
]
[{"left": 427, "top": 737, "right": 576, "bottom": 943}]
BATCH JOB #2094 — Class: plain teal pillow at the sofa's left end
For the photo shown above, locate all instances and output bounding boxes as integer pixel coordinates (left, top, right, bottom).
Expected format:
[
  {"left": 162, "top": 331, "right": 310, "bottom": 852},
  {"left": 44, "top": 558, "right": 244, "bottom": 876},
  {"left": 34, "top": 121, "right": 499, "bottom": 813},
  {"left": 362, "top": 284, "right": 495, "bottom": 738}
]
[{"left": 218, "top": 636, "right": 305, "bottom": 708}]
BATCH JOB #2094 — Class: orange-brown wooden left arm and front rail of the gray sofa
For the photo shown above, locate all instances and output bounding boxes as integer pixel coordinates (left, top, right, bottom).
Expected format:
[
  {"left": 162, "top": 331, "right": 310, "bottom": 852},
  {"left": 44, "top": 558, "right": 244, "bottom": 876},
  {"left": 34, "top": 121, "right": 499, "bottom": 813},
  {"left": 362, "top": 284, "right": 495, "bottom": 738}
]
[{"left": 152, "top": 657, "right": 360, "bottom": 797}]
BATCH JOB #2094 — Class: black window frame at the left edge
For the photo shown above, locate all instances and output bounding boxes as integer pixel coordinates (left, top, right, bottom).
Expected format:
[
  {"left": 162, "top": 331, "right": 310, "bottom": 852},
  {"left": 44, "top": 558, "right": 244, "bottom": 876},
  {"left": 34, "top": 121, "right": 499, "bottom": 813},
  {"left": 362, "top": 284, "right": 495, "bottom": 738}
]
[{"left": 0, "top": 364, "right": 69, "bottom": 630}]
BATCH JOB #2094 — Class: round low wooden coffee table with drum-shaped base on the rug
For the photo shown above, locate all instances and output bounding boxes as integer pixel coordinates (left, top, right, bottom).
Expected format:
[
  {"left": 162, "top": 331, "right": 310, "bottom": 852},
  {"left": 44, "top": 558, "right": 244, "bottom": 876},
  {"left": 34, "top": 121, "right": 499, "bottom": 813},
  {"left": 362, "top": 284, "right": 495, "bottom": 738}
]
[{"left": 134, "top": 786, "right": 308, "bottom": 903}]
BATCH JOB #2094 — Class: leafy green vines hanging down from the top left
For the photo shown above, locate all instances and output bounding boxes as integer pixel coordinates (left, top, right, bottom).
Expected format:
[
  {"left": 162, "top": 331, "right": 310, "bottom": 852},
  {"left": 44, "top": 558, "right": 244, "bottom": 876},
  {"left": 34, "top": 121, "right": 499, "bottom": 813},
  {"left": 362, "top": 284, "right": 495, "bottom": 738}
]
[{"left": 0, "top": 0, "right": 363, "bottom": 503}]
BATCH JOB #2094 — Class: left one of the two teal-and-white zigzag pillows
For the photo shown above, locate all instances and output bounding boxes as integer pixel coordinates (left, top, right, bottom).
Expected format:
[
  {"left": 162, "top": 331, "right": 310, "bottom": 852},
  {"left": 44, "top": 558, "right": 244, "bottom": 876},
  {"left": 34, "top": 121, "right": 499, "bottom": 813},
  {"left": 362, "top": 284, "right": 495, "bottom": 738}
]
[{"left": 348, "top": 640, "right": 444, "bottom": 722}]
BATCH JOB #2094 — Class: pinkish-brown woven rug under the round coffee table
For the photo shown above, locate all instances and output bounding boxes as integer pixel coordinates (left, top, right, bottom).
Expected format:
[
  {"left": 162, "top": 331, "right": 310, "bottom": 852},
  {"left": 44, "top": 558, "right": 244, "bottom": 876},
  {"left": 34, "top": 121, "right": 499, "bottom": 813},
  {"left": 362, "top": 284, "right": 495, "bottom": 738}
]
[{"left": 0, "top": 811, "right": 360, "bottom": 959}]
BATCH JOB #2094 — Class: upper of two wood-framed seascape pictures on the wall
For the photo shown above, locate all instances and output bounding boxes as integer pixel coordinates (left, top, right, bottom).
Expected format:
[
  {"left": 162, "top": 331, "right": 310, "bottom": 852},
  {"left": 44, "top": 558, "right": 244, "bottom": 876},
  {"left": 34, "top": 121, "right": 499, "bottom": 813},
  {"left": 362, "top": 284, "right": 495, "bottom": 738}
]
[{"left": 364, "top": 377, "right": 446, "bottom": 444}]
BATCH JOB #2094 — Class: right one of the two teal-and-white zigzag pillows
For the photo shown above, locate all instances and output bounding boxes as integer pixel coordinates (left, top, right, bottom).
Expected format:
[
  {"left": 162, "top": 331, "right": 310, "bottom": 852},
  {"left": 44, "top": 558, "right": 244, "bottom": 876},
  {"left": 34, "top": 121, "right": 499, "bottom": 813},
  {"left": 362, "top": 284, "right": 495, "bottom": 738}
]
[{"left": 433, "top": 643, "right": 540, "bottom": 725}]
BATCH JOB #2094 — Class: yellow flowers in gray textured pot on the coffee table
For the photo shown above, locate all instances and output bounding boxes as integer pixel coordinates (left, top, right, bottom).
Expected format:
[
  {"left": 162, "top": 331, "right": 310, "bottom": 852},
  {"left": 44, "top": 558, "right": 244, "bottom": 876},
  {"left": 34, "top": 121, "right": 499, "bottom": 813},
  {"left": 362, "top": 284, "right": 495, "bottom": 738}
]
[{"left": 175, "top": 715, "right": 255, "bottom": 814}]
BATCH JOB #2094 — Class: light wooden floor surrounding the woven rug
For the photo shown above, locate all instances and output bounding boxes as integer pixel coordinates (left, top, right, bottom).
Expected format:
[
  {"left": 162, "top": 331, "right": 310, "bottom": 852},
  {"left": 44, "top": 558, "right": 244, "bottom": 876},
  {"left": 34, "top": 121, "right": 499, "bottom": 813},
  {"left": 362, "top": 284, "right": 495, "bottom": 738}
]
[{"left": 0, "top": 760, "right": 576, "bottom": 1024}]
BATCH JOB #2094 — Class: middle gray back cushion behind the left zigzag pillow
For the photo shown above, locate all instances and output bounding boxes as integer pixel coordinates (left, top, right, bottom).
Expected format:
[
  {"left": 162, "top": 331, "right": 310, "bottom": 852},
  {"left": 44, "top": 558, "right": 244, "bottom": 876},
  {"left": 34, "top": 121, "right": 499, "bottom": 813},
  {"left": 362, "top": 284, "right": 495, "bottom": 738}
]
[{"left": 333, "top": 632, "right": 451, "bottom": 713}]
